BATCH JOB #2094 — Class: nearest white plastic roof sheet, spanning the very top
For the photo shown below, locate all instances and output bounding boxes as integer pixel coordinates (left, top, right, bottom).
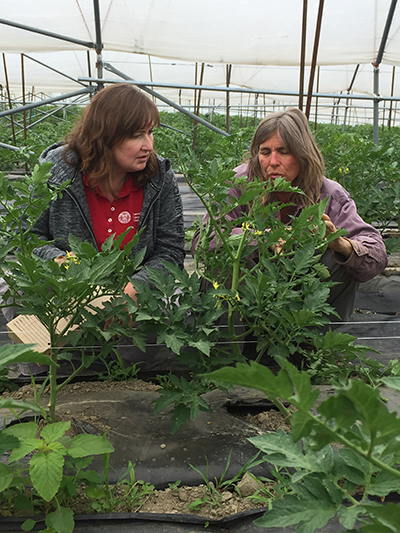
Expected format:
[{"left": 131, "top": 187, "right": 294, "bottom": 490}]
[{"left": 0, "top": 0, "right": 400, "bottom": 65}]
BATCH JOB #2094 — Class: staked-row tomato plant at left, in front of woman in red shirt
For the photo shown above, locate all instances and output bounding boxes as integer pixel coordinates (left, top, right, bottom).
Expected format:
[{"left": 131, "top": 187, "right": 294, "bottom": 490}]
[{"left": 0, "top": 164, "right": 150, "bottom": 421}]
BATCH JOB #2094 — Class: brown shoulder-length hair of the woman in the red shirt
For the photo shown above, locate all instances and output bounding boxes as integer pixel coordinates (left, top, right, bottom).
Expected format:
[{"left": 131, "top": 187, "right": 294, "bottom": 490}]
[{"left": 64, "top": 83, "right": 160, "bottom": 190}]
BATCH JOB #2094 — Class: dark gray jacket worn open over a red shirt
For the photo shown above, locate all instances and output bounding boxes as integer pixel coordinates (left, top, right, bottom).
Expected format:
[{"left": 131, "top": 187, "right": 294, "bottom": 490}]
[{"left": 33, "top": 143, "right": 185, "bottom": 281}]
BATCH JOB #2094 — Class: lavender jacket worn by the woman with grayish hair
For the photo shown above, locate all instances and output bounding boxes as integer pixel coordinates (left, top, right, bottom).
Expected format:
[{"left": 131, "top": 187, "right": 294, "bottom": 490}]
[{"left": 192, "top": 163, "right": 387, "bottom": 282}]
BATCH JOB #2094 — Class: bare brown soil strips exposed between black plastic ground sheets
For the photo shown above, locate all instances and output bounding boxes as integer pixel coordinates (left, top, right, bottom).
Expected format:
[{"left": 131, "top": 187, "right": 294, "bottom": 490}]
[{"left": 0, "top": 380, "right": 290, "bottom": 518}]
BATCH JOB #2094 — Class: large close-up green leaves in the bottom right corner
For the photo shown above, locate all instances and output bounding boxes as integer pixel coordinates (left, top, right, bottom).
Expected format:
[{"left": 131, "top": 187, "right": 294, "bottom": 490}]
[{"left": 203, "top": 362, "right": 400, "bottom": 533}]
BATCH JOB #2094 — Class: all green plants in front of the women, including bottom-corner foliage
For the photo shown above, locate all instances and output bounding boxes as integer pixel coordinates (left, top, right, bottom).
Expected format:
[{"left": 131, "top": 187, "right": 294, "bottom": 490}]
[{"left": 0, "top": 113, "right": 400, "bottom": 533}]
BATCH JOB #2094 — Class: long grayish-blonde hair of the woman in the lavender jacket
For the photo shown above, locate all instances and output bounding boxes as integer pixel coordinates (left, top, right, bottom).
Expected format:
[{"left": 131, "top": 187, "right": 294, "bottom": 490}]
[{"left": 248, "top": 108, "right": 325, "bottom": 206}]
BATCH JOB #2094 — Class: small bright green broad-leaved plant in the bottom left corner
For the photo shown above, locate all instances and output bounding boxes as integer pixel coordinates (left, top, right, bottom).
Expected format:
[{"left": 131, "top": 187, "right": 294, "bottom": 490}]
[{"left": 0, "top": 422, "right": 114, "bottom": 533}]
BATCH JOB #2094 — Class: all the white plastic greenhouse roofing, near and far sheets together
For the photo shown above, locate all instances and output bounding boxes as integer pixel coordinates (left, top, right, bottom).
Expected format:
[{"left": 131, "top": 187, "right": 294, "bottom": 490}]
[{"left": 0, "top": 0, "right": 400, "bottom": 119}]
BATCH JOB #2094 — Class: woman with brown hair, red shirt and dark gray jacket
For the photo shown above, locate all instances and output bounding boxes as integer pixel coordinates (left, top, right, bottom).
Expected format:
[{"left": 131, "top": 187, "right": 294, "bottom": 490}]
[{"left": 34, "top": 83, "right": 185, "bottom": 299}]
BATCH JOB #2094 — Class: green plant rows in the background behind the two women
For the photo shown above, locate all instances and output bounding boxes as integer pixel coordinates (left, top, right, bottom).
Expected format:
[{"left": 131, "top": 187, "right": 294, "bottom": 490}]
[{"left": 0, "top": 106, "right": 400, "bottom": 234}]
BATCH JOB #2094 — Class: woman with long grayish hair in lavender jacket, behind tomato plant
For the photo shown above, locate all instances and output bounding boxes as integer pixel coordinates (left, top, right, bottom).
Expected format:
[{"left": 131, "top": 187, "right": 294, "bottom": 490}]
[{"left": 192, "top": 108, "right": 387, "bottom": 321}]
